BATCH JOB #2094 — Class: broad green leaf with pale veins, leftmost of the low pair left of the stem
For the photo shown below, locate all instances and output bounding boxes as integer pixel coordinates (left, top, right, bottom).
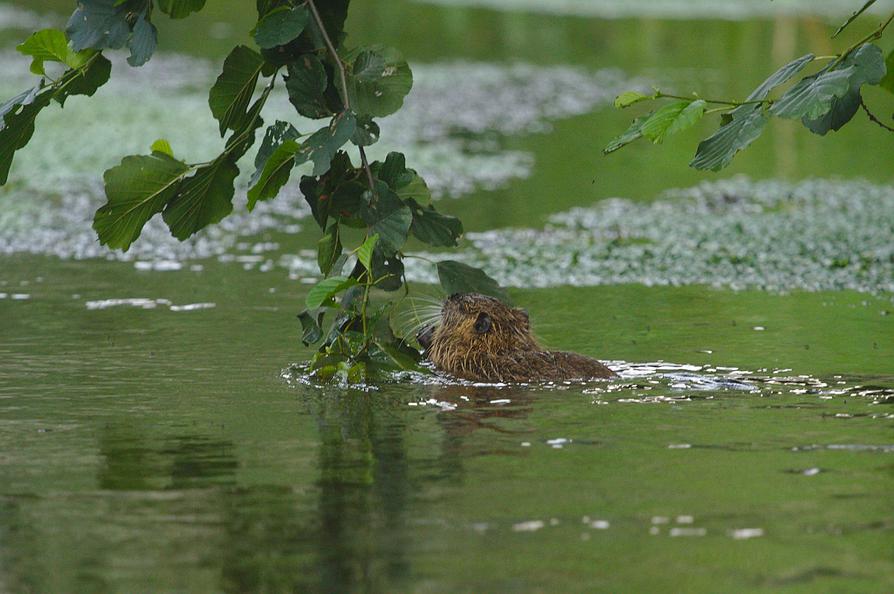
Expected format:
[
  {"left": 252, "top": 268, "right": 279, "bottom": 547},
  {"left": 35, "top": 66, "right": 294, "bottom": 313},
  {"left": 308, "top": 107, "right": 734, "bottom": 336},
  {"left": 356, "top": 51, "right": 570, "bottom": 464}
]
[{"left": 93, "top": 152, "right": 189, "bottom": 251}]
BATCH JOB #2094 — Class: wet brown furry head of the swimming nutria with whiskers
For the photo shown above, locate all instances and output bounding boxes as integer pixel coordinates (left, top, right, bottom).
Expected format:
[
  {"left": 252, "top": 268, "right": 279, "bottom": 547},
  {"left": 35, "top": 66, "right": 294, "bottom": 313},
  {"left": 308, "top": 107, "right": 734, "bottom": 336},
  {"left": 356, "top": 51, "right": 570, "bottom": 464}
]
[{"left": 416, "top": 293, "right": 540, "bottom": 377}]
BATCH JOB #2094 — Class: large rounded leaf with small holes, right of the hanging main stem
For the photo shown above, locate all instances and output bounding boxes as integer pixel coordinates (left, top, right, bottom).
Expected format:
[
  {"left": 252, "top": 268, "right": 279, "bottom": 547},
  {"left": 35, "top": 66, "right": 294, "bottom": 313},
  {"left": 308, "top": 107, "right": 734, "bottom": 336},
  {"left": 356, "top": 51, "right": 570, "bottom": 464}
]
[{"left": 339, "top": 45, "right": 413, "bottom": 117}]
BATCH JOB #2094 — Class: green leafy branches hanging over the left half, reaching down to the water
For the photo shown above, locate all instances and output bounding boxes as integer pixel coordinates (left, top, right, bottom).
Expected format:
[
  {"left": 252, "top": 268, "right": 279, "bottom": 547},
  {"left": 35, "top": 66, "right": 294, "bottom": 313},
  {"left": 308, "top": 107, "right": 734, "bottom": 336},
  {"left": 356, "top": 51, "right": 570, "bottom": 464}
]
[{"left": 0, "top": 0, "right": 499, "bottom": 380}]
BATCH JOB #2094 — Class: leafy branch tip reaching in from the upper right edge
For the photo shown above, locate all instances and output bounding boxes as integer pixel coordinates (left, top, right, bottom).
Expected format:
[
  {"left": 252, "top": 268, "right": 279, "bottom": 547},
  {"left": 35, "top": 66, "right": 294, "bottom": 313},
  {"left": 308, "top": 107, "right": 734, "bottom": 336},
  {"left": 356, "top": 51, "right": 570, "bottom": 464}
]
[{"left": 603, "top": 0, "right": 894, "bottom": 171}]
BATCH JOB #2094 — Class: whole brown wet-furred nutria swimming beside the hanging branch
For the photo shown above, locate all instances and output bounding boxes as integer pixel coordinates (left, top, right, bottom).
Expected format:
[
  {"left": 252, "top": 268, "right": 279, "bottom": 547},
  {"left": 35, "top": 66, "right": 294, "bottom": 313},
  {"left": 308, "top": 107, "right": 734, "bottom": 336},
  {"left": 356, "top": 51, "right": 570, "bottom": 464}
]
[{"left": 416, "top": 293, "right": 615, "bottom": 382}]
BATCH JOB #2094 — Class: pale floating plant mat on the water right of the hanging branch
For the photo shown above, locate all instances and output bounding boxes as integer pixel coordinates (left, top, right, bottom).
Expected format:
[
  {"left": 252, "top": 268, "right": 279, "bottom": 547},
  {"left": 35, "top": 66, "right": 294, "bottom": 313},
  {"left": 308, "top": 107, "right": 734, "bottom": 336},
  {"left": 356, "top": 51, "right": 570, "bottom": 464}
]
[{"left": 402, "top": 177, "right": 894, "bottom": 293}]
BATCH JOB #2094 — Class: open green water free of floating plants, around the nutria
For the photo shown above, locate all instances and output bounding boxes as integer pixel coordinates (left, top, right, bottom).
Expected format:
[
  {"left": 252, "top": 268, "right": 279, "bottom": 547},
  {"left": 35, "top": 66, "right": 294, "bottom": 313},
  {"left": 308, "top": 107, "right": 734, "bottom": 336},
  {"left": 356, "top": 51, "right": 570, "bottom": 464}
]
[{"left": 0, "top": 0, "right": 894, "bottom": 593}]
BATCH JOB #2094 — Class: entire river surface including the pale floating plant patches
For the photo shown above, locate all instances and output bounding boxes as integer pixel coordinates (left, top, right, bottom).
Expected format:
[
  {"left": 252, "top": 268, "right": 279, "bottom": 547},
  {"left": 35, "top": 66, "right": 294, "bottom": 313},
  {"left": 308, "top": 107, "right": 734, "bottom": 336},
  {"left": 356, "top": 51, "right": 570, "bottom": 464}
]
[{"left": 0, "top": 0, "right": 894, "bottom": 593}]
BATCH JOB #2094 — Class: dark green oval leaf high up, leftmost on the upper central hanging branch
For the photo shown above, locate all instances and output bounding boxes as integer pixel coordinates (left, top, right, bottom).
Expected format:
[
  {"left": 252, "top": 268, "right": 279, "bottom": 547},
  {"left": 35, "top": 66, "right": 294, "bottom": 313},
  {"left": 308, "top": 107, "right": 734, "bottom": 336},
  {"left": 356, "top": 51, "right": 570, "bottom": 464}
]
[{"left": 208, "top": 45, "right": 264, "bottom": 137}]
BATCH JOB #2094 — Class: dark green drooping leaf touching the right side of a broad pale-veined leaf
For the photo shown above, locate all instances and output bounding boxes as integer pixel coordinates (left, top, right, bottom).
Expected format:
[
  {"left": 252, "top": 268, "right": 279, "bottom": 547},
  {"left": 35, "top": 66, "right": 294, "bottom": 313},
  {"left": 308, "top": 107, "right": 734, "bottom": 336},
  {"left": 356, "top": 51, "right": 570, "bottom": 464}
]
[{"left": 162, "top": 155, "right": 239, "bottom": 241}]
